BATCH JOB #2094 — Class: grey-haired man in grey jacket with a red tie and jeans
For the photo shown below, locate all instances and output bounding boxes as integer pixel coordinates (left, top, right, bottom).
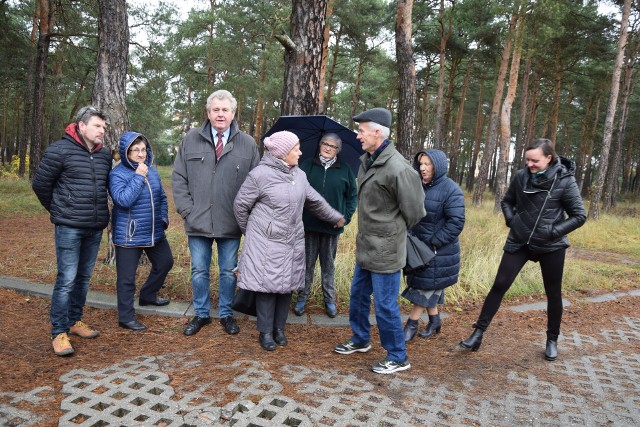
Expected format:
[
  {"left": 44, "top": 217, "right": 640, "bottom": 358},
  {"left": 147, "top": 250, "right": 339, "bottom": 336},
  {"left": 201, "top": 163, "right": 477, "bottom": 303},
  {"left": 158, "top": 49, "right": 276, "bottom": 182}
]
[{"left": 172, "top": 90, "right": 260, "bottom": 336}]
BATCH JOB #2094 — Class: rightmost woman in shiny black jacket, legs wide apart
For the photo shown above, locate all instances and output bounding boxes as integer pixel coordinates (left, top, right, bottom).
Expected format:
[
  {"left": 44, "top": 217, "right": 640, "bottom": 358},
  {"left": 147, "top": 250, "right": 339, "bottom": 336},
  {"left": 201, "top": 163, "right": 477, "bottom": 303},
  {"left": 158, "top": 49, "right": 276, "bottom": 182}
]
[{"left": 460, "top": 138, "right": 587, "bottom": 360}]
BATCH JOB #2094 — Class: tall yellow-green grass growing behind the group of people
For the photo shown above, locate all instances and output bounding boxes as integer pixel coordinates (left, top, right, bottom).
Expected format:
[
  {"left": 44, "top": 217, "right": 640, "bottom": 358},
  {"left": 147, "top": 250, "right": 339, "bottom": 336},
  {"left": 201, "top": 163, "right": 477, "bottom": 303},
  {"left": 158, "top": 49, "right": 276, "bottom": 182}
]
[{"left": 0, "top": 174, "right": 640, "bottom": 312}]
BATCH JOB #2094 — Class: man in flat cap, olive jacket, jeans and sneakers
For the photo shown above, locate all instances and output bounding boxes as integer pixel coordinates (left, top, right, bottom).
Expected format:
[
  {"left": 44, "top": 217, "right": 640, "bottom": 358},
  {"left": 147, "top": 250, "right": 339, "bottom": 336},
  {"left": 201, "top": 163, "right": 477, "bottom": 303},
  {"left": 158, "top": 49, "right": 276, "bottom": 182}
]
[{"left": 334, "top": 108, "right": 426, "bottom": 374}]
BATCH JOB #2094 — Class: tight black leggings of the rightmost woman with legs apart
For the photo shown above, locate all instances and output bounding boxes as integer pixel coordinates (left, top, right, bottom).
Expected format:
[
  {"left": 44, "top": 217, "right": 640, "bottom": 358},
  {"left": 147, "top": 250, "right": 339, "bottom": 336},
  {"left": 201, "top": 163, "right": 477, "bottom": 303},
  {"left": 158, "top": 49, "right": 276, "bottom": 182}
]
[{"left": 476, "top": 247, "right": 566, "bottom": 341}]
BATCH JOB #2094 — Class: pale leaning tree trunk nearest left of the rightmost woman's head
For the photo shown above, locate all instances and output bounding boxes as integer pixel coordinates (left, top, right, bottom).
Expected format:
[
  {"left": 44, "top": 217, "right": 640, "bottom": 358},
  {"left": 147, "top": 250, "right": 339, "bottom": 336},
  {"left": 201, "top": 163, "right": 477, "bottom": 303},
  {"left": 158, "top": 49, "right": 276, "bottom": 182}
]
[{"left": 493, "top": 15, "right": 524, "bottom": 213}]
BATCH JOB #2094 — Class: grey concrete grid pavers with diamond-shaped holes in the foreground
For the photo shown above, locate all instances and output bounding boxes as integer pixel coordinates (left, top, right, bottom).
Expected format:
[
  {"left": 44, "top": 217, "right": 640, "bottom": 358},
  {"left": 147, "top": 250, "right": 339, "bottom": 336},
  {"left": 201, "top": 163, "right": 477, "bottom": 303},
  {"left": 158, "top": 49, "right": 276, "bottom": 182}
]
[{"left": 0, "top": 277, "right": 640, "bottom": 427}]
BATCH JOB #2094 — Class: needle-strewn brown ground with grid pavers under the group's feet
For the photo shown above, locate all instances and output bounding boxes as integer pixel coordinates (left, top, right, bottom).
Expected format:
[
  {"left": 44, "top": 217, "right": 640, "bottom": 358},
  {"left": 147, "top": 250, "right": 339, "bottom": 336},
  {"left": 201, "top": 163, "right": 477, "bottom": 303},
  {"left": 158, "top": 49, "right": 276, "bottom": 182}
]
[{"left": 0, "top": 215, "right": 640, "bottom": 426}]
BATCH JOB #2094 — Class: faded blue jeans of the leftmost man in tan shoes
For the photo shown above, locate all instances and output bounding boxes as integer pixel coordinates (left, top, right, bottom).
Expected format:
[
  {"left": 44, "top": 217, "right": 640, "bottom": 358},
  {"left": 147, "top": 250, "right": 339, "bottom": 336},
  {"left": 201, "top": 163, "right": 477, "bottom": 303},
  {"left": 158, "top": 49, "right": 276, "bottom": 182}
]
[{"left": 50, "top": 225, "right": 102, "bottom": 337}]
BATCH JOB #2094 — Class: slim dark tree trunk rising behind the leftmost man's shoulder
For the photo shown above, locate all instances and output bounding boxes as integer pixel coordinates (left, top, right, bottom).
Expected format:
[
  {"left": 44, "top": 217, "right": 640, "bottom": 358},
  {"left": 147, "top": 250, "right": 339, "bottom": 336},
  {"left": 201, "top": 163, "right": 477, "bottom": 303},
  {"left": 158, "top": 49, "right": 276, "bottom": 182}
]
[{"left": 29, "top": 0, "right": 58, "bottom": 180}]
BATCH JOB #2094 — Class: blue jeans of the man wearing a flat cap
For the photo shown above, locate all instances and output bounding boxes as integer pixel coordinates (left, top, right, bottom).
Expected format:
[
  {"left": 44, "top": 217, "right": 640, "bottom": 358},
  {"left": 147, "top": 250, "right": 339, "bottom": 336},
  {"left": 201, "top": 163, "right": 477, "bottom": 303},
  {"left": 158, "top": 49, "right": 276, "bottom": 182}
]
[{"left": 349, "top": 264, "right": 407, "bottom": 362}]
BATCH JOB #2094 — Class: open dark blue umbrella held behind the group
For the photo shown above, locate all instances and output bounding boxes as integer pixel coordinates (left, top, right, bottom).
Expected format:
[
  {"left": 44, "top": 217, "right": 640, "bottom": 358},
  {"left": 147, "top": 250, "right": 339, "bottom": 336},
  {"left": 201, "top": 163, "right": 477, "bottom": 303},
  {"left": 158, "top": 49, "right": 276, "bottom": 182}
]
[{"left": 262, "top": 116, "right": 364, "bottom": 175}]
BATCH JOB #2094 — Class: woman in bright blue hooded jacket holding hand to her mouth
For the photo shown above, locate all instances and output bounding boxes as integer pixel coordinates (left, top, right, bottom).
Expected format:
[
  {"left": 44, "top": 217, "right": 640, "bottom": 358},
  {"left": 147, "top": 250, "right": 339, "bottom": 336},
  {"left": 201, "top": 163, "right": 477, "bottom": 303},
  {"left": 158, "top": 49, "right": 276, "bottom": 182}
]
[{"left": 109, "top": 132, "right": 173, "bottom": 331}]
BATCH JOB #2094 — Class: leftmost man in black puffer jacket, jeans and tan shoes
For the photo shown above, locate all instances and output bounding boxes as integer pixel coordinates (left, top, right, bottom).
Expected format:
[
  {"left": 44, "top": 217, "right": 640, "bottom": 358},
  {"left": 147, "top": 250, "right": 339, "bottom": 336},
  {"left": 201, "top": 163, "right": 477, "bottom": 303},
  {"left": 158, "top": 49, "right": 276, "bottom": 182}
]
[{"left": 32, "top": 106, "right": 111, "bottom": 356}]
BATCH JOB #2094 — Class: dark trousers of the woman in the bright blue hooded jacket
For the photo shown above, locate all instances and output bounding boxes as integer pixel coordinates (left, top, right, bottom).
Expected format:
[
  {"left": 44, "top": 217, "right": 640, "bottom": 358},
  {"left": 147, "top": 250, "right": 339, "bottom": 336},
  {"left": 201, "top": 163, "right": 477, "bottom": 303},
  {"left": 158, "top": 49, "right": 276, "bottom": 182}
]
[{"left": 115, "top": 239, "right": 173, "bottom": 322}]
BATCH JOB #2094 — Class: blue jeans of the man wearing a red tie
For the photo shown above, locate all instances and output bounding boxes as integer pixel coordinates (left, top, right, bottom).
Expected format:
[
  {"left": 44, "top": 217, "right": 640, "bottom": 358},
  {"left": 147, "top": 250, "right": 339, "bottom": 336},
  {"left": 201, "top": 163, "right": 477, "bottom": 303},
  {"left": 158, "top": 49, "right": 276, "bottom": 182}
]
[{"left": 189, "top": 236, "right": 240, "bottom": 318}]
